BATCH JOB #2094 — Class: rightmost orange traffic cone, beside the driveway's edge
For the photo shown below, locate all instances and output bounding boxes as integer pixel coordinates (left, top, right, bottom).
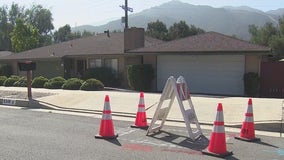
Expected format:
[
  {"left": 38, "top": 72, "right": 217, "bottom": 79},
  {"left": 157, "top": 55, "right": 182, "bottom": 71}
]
[{"left": 235, "top": 98, "right": 260, "bottom": 142}]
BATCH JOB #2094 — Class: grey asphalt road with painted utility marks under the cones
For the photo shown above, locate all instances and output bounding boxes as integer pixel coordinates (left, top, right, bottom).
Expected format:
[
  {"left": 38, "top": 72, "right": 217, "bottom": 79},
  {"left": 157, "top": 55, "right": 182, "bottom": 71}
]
[{"left": 0, "top": 107, "right": 284, "bottom": 160}]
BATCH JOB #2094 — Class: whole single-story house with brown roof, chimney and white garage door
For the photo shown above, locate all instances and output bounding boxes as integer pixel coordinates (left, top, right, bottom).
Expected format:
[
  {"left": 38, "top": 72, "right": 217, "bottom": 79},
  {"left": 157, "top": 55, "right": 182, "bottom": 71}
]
[{"left": 0, "top": 28, "right": 271, "bottom": 95}]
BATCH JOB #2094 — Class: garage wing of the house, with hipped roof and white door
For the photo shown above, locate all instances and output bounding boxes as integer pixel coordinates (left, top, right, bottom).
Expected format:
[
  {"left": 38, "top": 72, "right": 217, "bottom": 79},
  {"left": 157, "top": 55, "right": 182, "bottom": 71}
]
[{"left": 128, "top": 32, "right": 271, "bottom": 96}]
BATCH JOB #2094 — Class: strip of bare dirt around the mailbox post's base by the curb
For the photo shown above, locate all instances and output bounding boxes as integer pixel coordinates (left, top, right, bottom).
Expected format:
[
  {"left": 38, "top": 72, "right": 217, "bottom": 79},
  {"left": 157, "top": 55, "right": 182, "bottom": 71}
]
[{"left": 0, "top": 90, "right": 55, "bottom": 99}]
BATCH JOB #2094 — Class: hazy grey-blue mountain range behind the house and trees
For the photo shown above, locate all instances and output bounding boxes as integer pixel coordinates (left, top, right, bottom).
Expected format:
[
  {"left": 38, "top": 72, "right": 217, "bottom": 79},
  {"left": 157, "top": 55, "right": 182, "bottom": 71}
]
[{"left": 73, "top": 0, "right": 284, "bottom": 40}]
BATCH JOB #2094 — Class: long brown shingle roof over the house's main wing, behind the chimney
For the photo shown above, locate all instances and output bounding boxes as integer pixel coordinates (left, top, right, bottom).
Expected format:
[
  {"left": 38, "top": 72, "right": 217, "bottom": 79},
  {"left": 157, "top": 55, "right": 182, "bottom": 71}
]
[{"left": 0, "top": 33, "right": 161, "bottom": 60}]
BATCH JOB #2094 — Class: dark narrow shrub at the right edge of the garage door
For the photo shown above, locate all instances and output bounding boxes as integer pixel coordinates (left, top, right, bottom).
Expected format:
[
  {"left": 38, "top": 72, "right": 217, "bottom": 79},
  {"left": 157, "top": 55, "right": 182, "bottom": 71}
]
[{"left": 244, "top": 72, "right": 260, "bottom": 96}]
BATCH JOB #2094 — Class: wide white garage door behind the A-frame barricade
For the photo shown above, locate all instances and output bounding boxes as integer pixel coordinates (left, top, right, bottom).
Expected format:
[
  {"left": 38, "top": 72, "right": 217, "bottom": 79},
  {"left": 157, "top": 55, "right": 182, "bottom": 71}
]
[{"left": 157, "top": 55, "right": 245, "bottom": 95}]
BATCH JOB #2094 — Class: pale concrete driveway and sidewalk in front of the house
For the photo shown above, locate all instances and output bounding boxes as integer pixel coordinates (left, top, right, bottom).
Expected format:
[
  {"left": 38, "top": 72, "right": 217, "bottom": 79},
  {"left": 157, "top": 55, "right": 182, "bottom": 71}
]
[{"left": 0, "top": 87, "right": 283, "bottom": 135}]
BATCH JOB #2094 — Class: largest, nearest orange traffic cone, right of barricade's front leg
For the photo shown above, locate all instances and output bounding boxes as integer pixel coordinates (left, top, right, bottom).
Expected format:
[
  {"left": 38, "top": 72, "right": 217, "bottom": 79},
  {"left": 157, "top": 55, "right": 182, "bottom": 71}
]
[{"left": 202, "top": 103, "right": 233, "bottom": 158}]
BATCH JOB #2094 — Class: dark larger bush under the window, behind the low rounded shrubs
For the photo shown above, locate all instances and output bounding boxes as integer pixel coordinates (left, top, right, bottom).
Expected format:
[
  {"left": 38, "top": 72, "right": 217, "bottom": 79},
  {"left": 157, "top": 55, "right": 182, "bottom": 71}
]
[{"left": 83, "top": 67, "right": 120, "bottom": 87}]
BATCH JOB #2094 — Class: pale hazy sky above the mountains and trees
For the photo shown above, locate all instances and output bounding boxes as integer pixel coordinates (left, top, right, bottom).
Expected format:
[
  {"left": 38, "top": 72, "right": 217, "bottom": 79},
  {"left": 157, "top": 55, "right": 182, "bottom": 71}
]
[{"left": 0, "top": 0, "right": 284, "bottom": 28}]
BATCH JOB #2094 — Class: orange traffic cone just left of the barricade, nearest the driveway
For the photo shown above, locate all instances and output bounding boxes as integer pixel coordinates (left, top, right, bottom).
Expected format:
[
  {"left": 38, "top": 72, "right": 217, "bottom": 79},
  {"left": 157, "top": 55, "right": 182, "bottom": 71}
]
[{"left": 131, "top": 92, "right": 148, "bottom": 128}]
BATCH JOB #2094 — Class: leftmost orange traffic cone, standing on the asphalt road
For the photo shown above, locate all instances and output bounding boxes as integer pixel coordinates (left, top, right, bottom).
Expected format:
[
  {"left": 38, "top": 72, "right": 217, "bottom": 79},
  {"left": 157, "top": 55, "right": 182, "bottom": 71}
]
[{"left": 95, "top": 95, "right": 118, "bottom": 139}]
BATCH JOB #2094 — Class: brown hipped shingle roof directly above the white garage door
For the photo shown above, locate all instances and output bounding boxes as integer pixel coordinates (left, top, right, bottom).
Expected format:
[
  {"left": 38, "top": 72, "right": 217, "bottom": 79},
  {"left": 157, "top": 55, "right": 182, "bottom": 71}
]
[{"left": 129, "top": 32, "right": 271, "bottom": 53}]
